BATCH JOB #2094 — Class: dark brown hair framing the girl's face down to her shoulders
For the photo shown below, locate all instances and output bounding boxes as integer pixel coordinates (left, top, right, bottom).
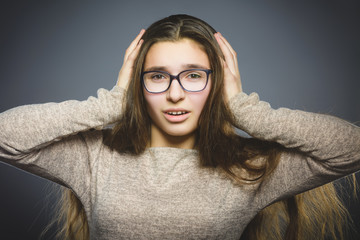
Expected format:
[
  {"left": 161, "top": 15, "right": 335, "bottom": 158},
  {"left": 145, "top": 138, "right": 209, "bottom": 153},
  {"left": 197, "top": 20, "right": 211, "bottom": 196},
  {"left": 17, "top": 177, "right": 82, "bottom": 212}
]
[{"left": 110, "top": 15, "right": 277, "bottom": 180}]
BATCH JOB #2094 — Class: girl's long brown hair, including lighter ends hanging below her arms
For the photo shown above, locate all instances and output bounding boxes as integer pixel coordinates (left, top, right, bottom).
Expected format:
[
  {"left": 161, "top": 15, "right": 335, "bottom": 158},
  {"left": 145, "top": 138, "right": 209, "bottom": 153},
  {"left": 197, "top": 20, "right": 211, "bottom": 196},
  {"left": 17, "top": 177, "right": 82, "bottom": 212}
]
[{"left": 54, "top": 15, "right": 354, "bottom": 240}]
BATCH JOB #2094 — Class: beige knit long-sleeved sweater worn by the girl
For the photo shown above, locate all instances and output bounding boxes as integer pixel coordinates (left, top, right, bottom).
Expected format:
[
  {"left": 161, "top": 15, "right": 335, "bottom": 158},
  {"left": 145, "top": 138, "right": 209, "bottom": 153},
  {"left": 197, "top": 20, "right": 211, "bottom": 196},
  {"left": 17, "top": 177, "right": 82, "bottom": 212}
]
[{"left": 0, "top": 87, "right": 360, "bottom": 240}]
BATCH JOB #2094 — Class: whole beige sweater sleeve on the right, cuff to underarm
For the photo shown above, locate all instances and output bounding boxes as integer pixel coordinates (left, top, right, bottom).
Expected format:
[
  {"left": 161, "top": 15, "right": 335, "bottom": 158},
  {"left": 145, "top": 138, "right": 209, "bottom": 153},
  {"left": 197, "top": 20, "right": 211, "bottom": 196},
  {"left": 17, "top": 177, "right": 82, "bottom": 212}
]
[{"left": 230, "top": 93, "right": 360, "bottom": 207}]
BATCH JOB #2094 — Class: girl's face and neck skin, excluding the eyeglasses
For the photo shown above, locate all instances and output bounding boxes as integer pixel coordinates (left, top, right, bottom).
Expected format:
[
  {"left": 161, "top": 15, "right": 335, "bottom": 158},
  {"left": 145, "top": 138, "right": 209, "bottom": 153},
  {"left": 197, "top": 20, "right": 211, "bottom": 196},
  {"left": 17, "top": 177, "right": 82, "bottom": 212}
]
[{"left": 143, "top": 39, "right": 211, "bottom": 148}]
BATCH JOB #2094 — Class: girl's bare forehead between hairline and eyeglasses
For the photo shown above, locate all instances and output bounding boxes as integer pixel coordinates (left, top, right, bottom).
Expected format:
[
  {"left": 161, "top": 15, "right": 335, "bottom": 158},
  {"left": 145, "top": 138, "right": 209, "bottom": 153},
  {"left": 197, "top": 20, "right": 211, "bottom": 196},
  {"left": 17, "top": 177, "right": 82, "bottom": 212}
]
[{"left": 144, "top": 38, "right": 210, "bottom": 73}]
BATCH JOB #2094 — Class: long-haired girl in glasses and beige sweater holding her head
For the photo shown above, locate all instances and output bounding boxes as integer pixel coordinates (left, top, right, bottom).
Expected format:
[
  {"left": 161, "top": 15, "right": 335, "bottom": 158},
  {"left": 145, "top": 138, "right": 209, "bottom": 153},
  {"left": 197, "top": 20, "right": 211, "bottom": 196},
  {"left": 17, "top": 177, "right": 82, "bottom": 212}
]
[{"left": 0, "top": 15, "right": 360, "bottom": 239}]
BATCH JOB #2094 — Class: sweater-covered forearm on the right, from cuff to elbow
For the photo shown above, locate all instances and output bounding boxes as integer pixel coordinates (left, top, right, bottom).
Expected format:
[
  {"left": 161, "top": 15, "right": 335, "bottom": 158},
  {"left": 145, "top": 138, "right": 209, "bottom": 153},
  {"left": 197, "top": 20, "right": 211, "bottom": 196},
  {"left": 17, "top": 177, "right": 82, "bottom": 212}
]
[{"left": 230, "top": 93, "right": 360, "bottom": 169}]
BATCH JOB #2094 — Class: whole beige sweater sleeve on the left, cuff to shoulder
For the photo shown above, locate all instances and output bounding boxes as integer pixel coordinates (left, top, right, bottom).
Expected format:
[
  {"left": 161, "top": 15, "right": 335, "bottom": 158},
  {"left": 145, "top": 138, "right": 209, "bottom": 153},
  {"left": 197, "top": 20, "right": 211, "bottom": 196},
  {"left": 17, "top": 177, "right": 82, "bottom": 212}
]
[{"left": 0, "top": 86, "right": 124, "bottom": 193}]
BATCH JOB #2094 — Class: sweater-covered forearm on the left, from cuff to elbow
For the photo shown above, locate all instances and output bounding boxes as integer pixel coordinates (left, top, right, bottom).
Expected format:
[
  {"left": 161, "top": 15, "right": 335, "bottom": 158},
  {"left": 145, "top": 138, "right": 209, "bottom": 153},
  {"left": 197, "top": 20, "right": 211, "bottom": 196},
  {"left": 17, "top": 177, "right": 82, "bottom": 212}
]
[{"left": 0, "top": 87, "right": 124, "bottom": 158}]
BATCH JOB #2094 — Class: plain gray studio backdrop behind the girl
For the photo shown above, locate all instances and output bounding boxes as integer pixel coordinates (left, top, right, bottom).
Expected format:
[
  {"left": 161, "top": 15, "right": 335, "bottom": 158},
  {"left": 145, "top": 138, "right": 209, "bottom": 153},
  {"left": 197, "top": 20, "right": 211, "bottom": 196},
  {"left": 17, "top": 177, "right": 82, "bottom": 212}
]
[{"left": 0, "top": 0, "right": 360, "bottom": 239}]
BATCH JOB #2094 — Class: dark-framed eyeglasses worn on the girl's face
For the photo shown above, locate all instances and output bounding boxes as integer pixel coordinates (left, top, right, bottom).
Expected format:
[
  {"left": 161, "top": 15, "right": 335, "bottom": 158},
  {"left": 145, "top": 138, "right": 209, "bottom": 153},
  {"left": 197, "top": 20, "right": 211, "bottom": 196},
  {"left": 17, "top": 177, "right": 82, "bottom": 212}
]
[{"left": 141, "top": 69, "right": 212, "bottom": 93}]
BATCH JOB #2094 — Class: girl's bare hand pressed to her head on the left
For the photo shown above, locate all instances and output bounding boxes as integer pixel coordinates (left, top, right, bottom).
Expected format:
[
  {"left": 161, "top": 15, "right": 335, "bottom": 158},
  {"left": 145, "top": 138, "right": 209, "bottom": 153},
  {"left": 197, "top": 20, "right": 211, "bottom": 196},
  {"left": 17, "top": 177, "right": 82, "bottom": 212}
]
[{"left": 117, "top": 29, "right": 145, "bottom": 90}]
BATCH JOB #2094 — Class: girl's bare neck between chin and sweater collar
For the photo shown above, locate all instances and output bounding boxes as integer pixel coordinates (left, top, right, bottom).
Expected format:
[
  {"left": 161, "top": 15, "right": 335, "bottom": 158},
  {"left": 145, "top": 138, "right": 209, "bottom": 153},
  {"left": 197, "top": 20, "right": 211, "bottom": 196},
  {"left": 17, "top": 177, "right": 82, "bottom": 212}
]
[{"left": 150, "top": 125, "right": 195, "bottom": 149}]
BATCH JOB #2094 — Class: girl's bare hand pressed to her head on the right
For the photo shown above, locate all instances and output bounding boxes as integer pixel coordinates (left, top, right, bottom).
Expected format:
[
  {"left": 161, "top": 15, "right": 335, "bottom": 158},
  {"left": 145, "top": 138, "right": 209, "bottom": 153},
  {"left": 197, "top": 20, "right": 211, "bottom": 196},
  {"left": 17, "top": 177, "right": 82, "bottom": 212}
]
[{"left": 215, "top": 33, "right": 242, "bottom": 102}]
